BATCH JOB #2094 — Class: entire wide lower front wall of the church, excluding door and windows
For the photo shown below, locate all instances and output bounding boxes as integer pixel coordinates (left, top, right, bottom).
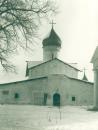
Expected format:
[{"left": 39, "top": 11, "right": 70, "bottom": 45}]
[{"left": 0, "top": 75, "right": 93, "bottom": 105}]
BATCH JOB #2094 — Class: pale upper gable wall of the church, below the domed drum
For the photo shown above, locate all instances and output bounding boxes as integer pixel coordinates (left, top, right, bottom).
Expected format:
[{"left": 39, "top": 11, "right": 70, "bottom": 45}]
[{"left": 29, "top": 60, "right": 78, "bottom": 78}]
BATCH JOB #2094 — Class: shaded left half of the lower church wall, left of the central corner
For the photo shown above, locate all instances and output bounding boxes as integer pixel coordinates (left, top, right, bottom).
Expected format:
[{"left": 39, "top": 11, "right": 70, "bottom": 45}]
[{"left": 0, "top": 78, "right": 46, "bottom": 105}]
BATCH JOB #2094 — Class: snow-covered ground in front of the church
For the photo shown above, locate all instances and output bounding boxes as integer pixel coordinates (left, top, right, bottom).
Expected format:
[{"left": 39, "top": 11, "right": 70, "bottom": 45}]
[{"left": 0, "top": 105, "right": 98, "bottom": 130}]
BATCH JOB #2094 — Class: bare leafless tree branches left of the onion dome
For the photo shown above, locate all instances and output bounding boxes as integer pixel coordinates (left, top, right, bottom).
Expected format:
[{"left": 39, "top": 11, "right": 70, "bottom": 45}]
[{"left": 0, "top": 0, "right": 55, "bottom": 70}]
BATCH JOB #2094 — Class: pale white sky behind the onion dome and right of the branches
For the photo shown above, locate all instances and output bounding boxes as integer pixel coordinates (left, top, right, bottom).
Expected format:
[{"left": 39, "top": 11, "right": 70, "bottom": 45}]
[{"left": 0, "top": 0, "right": 98, "bottom": 82}]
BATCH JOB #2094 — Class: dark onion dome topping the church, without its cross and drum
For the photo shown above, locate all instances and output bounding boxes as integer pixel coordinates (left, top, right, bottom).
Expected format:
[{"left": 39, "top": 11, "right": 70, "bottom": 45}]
[{"left": 43, "top": 27, "right": 61, "bottom": 47}]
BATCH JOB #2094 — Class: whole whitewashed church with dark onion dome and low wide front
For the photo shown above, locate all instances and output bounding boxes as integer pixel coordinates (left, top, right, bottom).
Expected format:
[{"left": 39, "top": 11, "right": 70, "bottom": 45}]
[{"left": 0, "top": 26, "right": 98, "bottom": 106}]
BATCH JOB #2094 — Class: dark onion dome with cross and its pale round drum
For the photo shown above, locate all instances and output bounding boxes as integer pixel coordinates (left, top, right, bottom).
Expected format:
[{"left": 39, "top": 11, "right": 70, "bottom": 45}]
[{"left": 42, "top": 21, "right": 61, "bottom": 61}]
